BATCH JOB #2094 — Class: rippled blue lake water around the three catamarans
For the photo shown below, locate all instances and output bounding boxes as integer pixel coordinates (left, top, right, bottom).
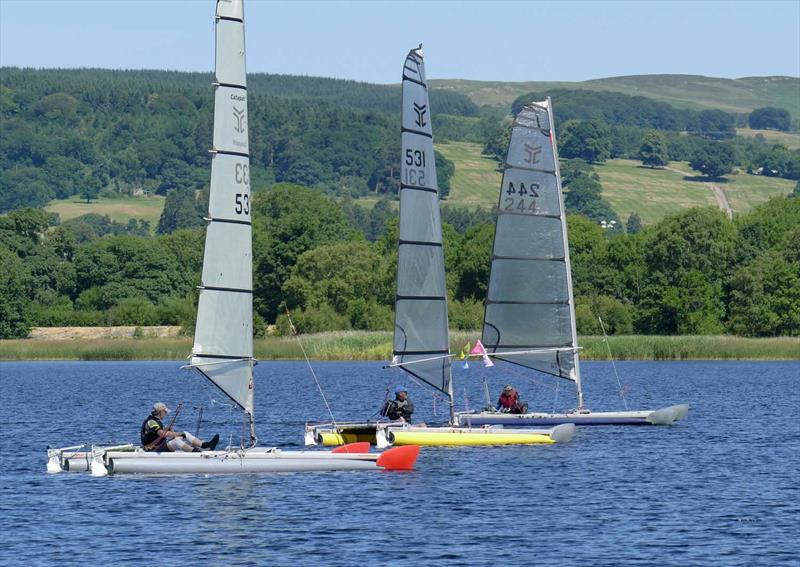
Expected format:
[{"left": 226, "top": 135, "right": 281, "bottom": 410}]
[{"left": 0, "top": 362, "right": 800, "bottom": 566}]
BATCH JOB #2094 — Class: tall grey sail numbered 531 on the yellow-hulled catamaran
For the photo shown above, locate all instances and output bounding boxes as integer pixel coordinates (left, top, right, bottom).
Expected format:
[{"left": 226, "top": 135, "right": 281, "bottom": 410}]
[{"left": 393, "top": 45, "right": 455, "bottom": 423}]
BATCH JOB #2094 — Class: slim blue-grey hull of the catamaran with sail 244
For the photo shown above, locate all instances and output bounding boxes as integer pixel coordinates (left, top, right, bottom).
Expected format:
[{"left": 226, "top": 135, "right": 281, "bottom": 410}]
[{"left": 456, "top": 404, "right": 689, "bottom": 427}]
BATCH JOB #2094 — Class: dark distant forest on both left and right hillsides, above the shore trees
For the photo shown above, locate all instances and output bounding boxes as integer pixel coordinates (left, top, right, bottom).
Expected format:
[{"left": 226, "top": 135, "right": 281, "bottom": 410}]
[{"left": 0, "top": 67, "right": 800, "bottom": 219}]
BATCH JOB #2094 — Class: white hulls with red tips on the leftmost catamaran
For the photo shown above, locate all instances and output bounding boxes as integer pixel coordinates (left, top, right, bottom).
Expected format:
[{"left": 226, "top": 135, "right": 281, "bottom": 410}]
[{"left": 47, "top": 444, "right": 419, "bottom": 476}]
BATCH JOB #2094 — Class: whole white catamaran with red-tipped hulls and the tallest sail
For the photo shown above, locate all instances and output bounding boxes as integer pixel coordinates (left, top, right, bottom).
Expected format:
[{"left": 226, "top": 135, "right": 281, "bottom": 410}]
[{"left": 43, "top": 0, "right": 419, "bottom": 476}]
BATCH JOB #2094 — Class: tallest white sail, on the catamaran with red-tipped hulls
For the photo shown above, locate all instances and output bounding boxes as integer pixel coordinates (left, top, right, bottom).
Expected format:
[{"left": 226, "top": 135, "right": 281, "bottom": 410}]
[{"left": 191, "top": 0, "right": 253, "bottom": 422}]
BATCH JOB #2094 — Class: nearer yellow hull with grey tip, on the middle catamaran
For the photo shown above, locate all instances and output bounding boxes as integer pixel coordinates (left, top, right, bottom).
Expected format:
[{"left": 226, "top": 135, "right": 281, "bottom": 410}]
[{"left": 377, "top": 423, "right": 575, "bottom": 447}]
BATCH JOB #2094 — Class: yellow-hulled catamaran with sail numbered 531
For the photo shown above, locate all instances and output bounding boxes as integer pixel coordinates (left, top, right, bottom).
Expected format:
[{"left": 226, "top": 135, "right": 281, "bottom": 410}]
[{"left": 306, "top": 46, "right": 574, "bottom": 447}]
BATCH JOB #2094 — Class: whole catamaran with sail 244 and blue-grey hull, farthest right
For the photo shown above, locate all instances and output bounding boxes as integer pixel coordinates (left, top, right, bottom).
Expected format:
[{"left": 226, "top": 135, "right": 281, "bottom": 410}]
[{"left": 456, "top": 98, "right": 689, "bottom": 426}]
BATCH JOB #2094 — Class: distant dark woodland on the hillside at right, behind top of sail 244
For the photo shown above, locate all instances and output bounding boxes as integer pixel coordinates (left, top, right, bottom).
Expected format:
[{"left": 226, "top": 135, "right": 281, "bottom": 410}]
[{"left": 496, "top": 89, "right": 800, "bottom": 179}]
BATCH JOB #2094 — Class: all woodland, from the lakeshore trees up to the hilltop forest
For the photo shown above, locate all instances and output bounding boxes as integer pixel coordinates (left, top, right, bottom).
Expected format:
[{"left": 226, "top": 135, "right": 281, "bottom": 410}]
[{"left": 0, "top": 68, "right": 800, "bottom": 338}]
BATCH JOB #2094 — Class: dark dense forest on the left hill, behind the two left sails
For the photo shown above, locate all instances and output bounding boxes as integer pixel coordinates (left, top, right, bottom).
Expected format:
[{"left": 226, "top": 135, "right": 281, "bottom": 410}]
[{"left": 0, "top": 68, "right": 478, "bottom": 212}]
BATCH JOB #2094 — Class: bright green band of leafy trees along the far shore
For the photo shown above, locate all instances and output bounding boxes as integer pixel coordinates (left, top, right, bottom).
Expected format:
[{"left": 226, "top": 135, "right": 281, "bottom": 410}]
[{"left": 0, "top": 184, "right": 800, "bottom": 338}]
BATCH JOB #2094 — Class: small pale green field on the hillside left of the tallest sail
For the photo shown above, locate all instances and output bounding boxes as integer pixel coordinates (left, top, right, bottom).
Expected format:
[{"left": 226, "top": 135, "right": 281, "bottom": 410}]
[{"left": 45, "top": 195, "right": 166, "bottom": 232}]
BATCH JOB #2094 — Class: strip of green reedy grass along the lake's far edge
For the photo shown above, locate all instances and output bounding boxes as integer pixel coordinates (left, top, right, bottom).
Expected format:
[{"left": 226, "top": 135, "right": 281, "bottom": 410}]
[{"left": 0, "top": 331, "right": 800, "bottom": 360}]
